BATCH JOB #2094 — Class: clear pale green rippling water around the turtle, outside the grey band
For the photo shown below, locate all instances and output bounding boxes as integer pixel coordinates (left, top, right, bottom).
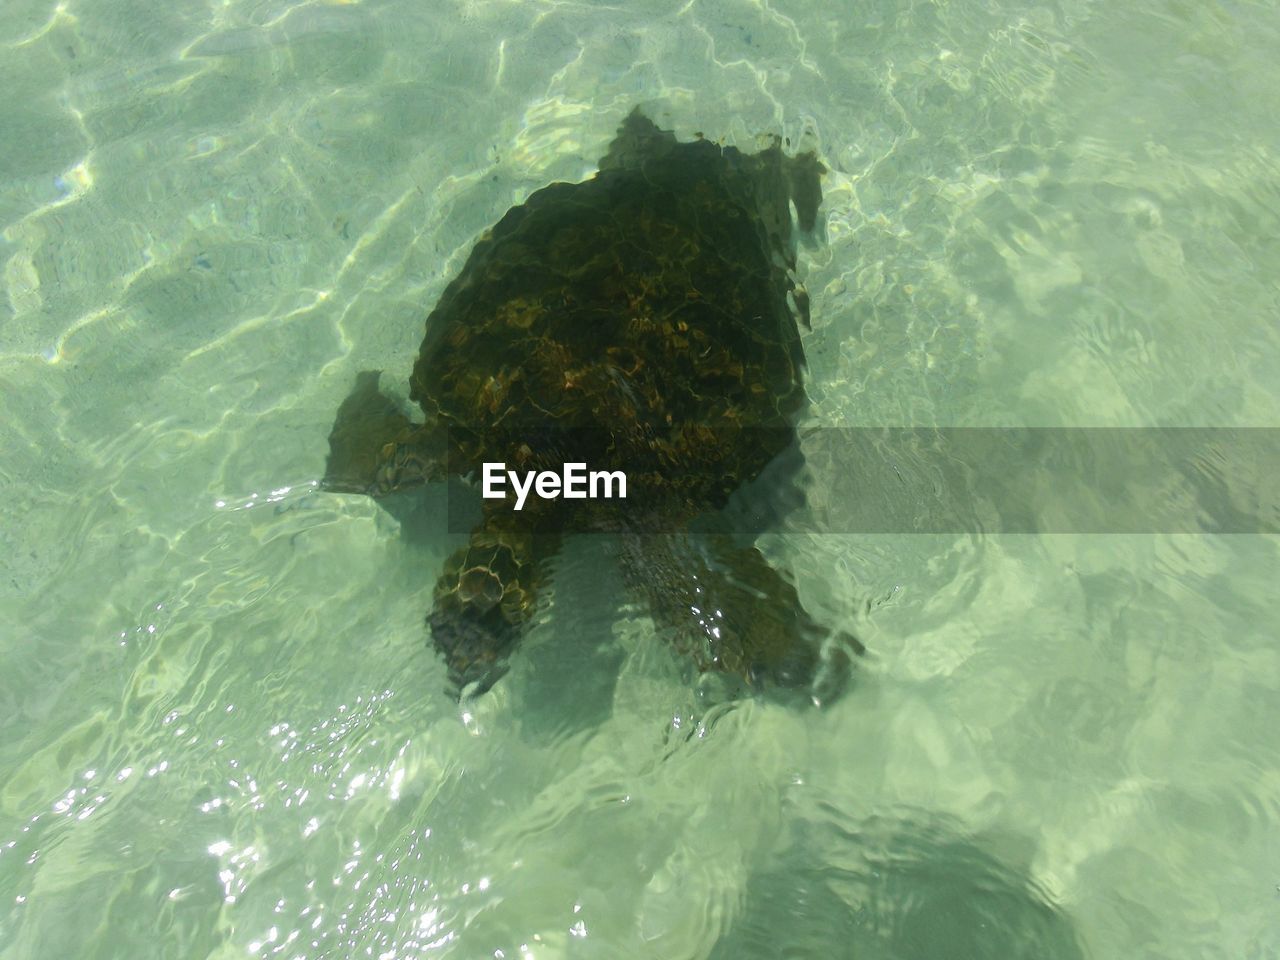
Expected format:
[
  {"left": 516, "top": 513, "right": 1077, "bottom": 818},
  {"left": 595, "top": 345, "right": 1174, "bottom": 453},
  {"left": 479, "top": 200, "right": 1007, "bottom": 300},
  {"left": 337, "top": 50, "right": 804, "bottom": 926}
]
[{"left": 0, "top": 3, "right": 1280, "bottom": 960}]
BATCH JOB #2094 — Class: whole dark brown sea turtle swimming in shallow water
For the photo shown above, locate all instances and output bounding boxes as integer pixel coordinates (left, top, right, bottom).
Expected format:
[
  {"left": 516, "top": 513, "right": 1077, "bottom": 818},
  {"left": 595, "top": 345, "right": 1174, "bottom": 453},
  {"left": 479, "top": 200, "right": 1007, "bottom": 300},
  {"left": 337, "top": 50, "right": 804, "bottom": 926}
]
[{"left": 324, "top": 110, "right": 861, "bottom": 699}]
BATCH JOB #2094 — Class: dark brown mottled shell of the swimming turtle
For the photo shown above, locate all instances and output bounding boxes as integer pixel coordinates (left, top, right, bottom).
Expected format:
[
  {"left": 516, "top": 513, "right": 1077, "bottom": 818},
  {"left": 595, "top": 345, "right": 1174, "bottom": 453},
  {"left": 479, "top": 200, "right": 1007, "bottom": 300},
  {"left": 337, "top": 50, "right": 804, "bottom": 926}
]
[{"left": 410, "top": 113, "right": 822, "bottom": 514}]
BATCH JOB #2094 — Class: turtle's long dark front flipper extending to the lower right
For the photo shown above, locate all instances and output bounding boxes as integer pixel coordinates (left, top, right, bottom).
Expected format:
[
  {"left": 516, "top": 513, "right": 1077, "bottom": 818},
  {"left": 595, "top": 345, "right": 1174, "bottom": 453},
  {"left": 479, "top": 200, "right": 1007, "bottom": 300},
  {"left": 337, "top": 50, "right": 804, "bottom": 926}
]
[{"left": 623, "top": 534, "right": 865, "bottom": 704}]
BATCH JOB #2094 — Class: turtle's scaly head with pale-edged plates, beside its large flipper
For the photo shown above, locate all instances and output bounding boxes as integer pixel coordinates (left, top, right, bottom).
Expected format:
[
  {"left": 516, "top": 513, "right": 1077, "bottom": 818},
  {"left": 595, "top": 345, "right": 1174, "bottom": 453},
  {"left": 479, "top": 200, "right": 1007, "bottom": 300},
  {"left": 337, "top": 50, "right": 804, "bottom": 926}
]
[{"left": 426, "top": 506, "right": 559, "bottom": 696}]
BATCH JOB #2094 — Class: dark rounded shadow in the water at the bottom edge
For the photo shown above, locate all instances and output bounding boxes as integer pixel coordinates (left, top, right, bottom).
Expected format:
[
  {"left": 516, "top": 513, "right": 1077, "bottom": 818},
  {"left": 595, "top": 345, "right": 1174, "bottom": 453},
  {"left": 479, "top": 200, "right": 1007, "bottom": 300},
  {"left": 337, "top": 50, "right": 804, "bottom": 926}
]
[{"left": 710, "top": 817, "right": 1085, "bottom": 960}]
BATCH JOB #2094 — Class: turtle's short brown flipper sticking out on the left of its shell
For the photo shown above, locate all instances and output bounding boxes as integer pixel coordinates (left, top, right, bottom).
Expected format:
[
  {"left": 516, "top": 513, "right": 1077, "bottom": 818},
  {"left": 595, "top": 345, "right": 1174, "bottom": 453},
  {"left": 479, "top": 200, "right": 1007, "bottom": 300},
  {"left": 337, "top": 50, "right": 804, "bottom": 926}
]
[{"left": 323, "top": 370, "right": 444, "bottom": 497}]
